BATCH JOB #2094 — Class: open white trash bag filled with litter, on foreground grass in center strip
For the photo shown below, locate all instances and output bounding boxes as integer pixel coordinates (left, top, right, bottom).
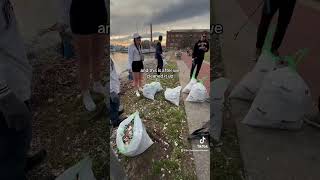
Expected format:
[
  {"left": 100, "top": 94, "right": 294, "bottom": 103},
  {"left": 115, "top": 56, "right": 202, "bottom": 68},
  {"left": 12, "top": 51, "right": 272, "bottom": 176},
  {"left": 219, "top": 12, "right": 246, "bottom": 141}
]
[{"left": 116, "top": 112, "right": 153, "bottom": 157}]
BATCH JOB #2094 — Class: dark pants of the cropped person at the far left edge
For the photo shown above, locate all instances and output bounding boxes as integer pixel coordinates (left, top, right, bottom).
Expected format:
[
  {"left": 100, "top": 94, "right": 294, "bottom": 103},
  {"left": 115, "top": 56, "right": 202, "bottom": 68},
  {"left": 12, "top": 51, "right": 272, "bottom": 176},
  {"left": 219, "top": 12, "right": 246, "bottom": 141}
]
[{"left": 0, "top": 100, "right": 32, "bottom": 180}]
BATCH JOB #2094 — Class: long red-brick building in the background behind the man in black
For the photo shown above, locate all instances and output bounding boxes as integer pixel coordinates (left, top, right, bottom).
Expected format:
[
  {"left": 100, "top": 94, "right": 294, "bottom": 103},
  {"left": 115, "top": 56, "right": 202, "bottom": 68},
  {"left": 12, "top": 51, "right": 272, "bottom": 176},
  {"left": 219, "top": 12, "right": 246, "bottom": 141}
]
[{"left": 166, "top": 29, "right": 210, "bottom": 49}]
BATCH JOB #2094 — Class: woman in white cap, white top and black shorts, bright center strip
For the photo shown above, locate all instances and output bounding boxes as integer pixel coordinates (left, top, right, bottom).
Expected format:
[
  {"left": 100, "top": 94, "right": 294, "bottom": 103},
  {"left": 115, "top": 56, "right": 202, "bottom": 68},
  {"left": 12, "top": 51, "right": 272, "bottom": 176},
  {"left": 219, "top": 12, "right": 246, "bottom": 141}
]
[{"left": 128, "top": 33, "right": 144, "bottom": 97}]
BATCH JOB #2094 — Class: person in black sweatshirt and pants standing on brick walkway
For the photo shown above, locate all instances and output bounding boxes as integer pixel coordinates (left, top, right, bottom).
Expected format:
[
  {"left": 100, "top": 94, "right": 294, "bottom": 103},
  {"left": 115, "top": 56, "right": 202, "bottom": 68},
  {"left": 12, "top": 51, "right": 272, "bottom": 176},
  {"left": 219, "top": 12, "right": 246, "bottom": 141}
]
[{"left": 190, "top": 34, "right": 209, "bottom": 78}]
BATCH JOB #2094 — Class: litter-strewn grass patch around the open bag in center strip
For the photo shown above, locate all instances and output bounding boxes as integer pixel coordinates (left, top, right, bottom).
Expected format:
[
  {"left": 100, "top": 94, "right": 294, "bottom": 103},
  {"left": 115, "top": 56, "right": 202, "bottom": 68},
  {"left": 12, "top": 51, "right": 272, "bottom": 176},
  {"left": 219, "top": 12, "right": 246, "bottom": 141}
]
[{"left": 114, "top": 52, "right": 196, "bottom": 180}]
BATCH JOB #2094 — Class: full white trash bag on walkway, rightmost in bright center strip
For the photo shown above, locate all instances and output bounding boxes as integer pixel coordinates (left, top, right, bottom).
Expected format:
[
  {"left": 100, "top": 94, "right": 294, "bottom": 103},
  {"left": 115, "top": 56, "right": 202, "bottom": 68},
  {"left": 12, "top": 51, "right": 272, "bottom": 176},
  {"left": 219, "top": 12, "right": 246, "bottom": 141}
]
[{"left": 186, "top": 82, "right": 208, "bottom": 102}]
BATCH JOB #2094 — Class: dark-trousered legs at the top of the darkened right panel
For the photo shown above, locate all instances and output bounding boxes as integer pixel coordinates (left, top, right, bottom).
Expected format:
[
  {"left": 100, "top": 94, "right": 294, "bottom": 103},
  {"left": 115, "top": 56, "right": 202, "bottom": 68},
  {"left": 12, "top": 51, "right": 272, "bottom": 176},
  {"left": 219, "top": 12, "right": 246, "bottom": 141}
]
[{"left": 256, "top": 0, "right": 296, "bottom": 60}]
